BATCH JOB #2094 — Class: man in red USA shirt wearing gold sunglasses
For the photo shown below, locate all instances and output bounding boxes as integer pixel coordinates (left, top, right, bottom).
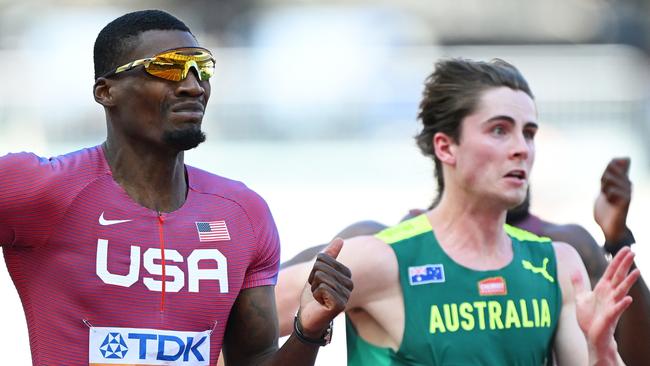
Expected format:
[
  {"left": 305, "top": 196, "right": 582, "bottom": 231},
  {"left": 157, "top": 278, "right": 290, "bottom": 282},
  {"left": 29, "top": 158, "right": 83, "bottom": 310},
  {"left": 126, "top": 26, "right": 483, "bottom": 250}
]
[{"left": 0, "top": 10, "right": 352, "bottom": 366}]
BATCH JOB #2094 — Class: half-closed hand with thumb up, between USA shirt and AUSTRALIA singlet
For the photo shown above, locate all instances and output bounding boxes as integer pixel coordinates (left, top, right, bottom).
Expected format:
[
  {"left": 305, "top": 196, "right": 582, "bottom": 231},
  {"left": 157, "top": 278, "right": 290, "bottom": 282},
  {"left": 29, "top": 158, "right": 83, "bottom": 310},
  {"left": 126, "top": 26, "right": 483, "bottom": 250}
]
[{"left": 298, "top": 238, "right": 353, "bottom": 338}]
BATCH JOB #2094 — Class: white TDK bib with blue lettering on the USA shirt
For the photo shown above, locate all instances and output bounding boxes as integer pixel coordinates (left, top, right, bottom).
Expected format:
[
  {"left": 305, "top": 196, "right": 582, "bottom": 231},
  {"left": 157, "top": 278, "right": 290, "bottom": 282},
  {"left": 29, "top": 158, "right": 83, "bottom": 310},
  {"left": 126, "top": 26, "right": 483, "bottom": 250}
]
[{"left": 89, "top": 327, "right": 210, "bottom": 366}]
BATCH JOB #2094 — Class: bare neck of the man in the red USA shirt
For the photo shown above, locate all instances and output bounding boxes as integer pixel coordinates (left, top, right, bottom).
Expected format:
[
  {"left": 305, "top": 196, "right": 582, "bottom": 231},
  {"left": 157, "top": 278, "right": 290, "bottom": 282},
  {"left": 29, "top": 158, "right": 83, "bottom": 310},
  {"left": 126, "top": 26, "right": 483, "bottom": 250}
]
[{"left": 102, "top": 140, "right": 187, "bottom": 212}]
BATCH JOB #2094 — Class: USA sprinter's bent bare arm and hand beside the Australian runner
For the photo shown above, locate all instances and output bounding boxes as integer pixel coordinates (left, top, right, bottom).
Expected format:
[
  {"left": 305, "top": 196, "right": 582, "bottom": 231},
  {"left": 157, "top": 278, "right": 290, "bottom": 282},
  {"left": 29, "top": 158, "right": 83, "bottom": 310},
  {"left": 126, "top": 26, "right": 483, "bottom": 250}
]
[{"left": 223, "top": 240, "right": 352, "bottom": 366}]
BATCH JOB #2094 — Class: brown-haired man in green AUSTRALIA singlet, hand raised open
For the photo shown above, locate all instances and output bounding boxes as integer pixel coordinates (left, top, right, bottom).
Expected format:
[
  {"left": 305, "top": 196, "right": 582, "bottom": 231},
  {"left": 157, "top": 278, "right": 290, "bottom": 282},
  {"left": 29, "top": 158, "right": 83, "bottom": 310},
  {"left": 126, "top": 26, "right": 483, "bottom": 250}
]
[{"left": 277, "top": 59, "right": 639, "bottom": 365}]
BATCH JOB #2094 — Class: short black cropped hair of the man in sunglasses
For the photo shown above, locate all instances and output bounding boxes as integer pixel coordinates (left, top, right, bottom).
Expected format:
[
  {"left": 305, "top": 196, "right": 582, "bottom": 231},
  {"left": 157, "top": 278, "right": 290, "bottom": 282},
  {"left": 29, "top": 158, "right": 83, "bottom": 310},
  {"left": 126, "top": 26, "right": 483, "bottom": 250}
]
[{"left": 93, "top": 10, "right": 192, "bottom": 79}]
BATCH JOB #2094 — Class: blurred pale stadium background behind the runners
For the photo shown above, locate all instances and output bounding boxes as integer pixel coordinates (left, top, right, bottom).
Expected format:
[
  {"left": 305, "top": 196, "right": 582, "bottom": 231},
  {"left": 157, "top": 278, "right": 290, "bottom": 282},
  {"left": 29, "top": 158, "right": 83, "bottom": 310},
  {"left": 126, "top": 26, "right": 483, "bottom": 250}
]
[{"left": 0, "top": 0, "right": 650, "bottom": 365}]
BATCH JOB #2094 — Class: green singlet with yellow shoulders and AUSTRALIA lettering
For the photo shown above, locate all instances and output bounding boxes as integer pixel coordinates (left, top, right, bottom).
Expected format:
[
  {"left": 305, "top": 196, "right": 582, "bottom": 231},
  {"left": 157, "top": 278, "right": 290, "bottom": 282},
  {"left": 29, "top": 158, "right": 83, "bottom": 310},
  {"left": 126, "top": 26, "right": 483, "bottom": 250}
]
[{"left": 347, "top": 215, "right": 562, "bottom": 366}]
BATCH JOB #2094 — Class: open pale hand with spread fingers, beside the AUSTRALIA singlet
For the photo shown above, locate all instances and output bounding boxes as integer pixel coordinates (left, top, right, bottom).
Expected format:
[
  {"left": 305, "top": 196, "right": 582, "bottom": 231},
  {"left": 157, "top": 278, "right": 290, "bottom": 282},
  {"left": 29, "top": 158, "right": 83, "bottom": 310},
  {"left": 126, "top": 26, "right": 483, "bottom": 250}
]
[{"left": 571, "top": 247, "right": 640, "bottom": 349}]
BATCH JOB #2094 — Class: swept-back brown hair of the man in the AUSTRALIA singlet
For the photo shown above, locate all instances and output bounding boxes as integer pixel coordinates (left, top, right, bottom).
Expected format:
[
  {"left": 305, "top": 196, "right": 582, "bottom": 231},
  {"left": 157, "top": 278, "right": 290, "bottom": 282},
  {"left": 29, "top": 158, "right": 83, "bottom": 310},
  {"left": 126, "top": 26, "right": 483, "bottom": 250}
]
[{"left": 415, "top": 58, "right": 534, "bottom": 206}]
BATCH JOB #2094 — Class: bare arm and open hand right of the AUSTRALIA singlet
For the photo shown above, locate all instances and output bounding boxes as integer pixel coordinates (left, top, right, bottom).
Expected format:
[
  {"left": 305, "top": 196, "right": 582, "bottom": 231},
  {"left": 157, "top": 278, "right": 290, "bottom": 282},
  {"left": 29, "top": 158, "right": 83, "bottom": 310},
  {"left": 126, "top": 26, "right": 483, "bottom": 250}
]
[{"left": 553, "top": 243, "right": 639, "bottom": 365}]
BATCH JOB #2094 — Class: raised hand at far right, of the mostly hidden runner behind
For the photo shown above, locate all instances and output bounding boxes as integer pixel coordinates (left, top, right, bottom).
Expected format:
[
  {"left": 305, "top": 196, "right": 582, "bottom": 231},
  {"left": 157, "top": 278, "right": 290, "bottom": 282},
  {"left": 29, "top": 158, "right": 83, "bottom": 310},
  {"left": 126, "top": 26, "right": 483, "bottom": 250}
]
[{"left": 594, "top": 158, "right": 632, "bottom": 243}]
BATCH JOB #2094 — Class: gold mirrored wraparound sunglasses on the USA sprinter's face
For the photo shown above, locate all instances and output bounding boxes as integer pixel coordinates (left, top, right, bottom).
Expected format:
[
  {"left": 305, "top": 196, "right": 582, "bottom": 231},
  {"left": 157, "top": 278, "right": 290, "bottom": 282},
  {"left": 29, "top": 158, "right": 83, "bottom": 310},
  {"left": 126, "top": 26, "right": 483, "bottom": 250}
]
[{"left": 102, "top": 47, "right": 214, "bottom": 81}]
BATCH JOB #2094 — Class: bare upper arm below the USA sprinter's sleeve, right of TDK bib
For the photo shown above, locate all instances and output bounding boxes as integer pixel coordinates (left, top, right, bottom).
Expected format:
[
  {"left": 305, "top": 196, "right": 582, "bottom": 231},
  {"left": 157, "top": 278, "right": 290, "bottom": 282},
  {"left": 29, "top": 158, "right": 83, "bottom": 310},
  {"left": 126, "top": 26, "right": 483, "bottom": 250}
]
[{"left": 223, "top": 286, "right": 279, "bottom": 365}]
